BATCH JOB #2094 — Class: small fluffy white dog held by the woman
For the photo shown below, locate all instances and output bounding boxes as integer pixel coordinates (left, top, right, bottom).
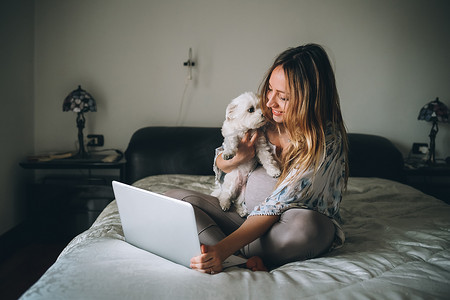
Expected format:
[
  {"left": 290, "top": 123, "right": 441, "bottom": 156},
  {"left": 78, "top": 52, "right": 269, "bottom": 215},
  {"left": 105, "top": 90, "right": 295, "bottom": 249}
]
[{"left": 212, "top": 92, "right": 281, "bottom": 217}]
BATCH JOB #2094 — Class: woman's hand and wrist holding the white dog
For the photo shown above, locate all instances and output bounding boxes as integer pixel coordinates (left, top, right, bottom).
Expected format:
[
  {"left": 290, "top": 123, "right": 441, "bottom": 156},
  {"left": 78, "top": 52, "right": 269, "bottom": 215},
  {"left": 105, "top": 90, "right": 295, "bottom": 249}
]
[{"left": 216, "top": 130, "right": 260, "bottom": 173}]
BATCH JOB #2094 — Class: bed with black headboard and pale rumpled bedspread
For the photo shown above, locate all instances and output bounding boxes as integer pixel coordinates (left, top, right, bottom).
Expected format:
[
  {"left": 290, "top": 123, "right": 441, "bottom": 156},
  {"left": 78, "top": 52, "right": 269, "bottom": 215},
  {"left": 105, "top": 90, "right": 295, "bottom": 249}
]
[{"left": 21, "top": 127, "right": 450, "bottom": 299}]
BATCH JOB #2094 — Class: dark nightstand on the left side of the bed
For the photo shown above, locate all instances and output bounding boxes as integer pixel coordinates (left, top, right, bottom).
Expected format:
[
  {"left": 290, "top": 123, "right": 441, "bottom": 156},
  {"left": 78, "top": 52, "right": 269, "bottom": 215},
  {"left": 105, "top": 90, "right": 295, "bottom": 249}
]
[{"left": 20, "top": 155, "right": 125, "bottom": 240}]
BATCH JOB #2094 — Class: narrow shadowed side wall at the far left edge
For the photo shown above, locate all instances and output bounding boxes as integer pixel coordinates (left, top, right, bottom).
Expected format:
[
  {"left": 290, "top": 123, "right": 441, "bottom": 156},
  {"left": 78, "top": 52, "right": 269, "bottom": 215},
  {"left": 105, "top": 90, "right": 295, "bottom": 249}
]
[{"left": 0, "top": 0, "right": 34, "bottom": 234}]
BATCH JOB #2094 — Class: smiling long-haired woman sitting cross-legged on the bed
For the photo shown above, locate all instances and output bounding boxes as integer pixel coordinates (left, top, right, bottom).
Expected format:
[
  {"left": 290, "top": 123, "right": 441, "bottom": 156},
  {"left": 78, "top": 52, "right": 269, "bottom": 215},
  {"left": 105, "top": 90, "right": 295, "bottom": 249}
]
[{"left": 167, "top": 44, "right": 348, "bottom": 274}]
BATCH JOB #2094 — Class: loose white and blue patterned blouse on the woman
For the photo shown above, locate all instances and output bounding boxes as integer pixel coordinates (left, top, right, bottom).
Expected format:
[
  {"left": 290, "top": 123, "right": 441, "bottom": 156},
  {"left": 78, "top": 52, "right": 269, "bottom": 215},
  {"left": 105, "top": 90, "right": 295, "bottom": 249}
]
[{"left": 214, "top": 127, "right": 346, "bottom": 248}]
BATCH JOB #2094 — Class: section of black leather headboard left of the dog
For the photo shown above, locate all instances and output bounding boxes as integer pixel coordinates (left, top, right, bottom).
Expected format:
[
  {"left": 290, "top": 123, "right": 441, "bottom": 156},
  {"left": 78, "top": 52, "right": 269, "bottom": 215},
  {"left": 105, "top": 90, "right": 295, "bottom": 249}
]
[{"left": 125, "top": 127, "right": 223, "bottom": 183}]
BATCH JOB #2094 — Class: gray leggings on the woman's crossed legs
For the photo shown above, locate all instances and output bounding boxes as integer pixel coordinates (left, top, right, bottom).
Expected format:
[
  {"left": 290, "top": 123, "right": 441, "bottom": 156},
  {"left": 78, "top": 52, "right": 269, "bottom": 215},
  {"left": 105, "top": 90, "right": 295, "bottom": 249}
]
[{"left": 166, "top": 172, "right": 335, "bottom": 267}]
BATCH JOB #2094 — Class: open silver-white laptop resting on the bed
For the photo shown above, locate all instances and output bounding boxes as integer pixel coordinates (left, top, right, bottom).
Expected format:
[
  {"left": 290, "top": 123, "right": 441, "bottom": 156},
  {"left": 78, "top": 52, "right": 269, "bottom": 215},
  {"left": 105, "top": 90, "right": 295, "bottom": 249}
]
[{"left": 112, "top": 181, "right": 247, "bottom": 268}]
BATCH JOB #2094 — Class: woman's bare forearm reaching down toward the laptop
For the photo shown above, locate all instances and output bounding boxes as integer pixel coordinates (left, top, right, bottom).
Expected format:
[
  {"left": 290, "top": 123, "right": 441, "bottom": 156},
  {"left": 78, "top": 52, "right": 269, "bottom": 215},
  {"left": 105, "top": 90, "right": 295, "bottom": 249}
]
[{"left": 216, "top": 216, "right": 280, "bottom": 261}]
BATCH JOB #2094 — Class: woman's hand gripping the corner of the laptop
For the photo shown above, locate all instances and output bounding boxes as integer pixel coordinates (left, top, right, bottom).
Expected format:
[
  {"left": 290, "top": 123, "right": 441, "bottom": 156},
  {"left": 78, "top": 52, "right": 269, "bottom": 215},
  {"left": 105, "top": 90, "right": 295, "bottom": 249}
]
[{"left": 191, "top": 245, "right": 223, "bottom": 274}]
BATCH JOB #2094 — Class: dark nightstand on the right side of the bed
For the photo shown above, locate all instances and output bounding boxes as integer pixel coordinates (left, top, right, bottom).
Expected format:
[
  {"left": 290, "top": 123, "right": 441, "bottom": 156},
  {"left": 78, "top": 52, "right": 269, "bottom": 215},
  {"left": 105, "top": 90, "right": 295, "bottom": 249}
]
[{"left": 405, "top": 164, "right": 450, "bottom": 204}]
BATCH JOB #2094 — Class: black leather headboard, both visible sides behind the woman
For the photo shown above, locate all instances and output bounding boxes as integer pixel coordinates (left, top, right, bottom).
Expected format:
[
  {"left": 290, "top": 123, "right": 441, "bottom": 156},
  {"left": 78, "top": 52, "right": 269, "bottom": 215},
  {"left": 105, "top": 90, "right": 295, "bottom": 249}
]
[{"left": 125, "top": 127, "right": 403, "bottom": 183}]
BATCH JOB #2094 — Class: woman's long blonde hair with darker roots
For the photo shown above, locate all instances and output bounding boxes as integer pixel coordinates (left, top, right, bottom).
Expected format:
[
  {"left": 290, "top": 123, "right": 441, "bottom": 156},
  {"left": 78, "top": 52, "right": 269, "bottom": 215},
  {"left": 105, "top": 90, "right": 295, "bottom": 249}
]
[{"left": 259, "top": 44, "right": 348, "bottom": 184}]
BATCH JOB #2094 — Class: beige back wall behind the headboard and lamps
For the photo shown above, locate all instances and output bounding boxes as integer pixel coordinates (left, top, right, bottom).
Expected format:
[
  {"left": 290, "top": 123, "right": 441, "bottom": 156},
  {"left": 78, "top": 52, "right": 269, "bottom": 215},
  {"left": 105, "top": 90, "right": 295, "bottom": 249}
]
[{"left": 35, "top": 0, "right": 450, "bottom": 157}]
